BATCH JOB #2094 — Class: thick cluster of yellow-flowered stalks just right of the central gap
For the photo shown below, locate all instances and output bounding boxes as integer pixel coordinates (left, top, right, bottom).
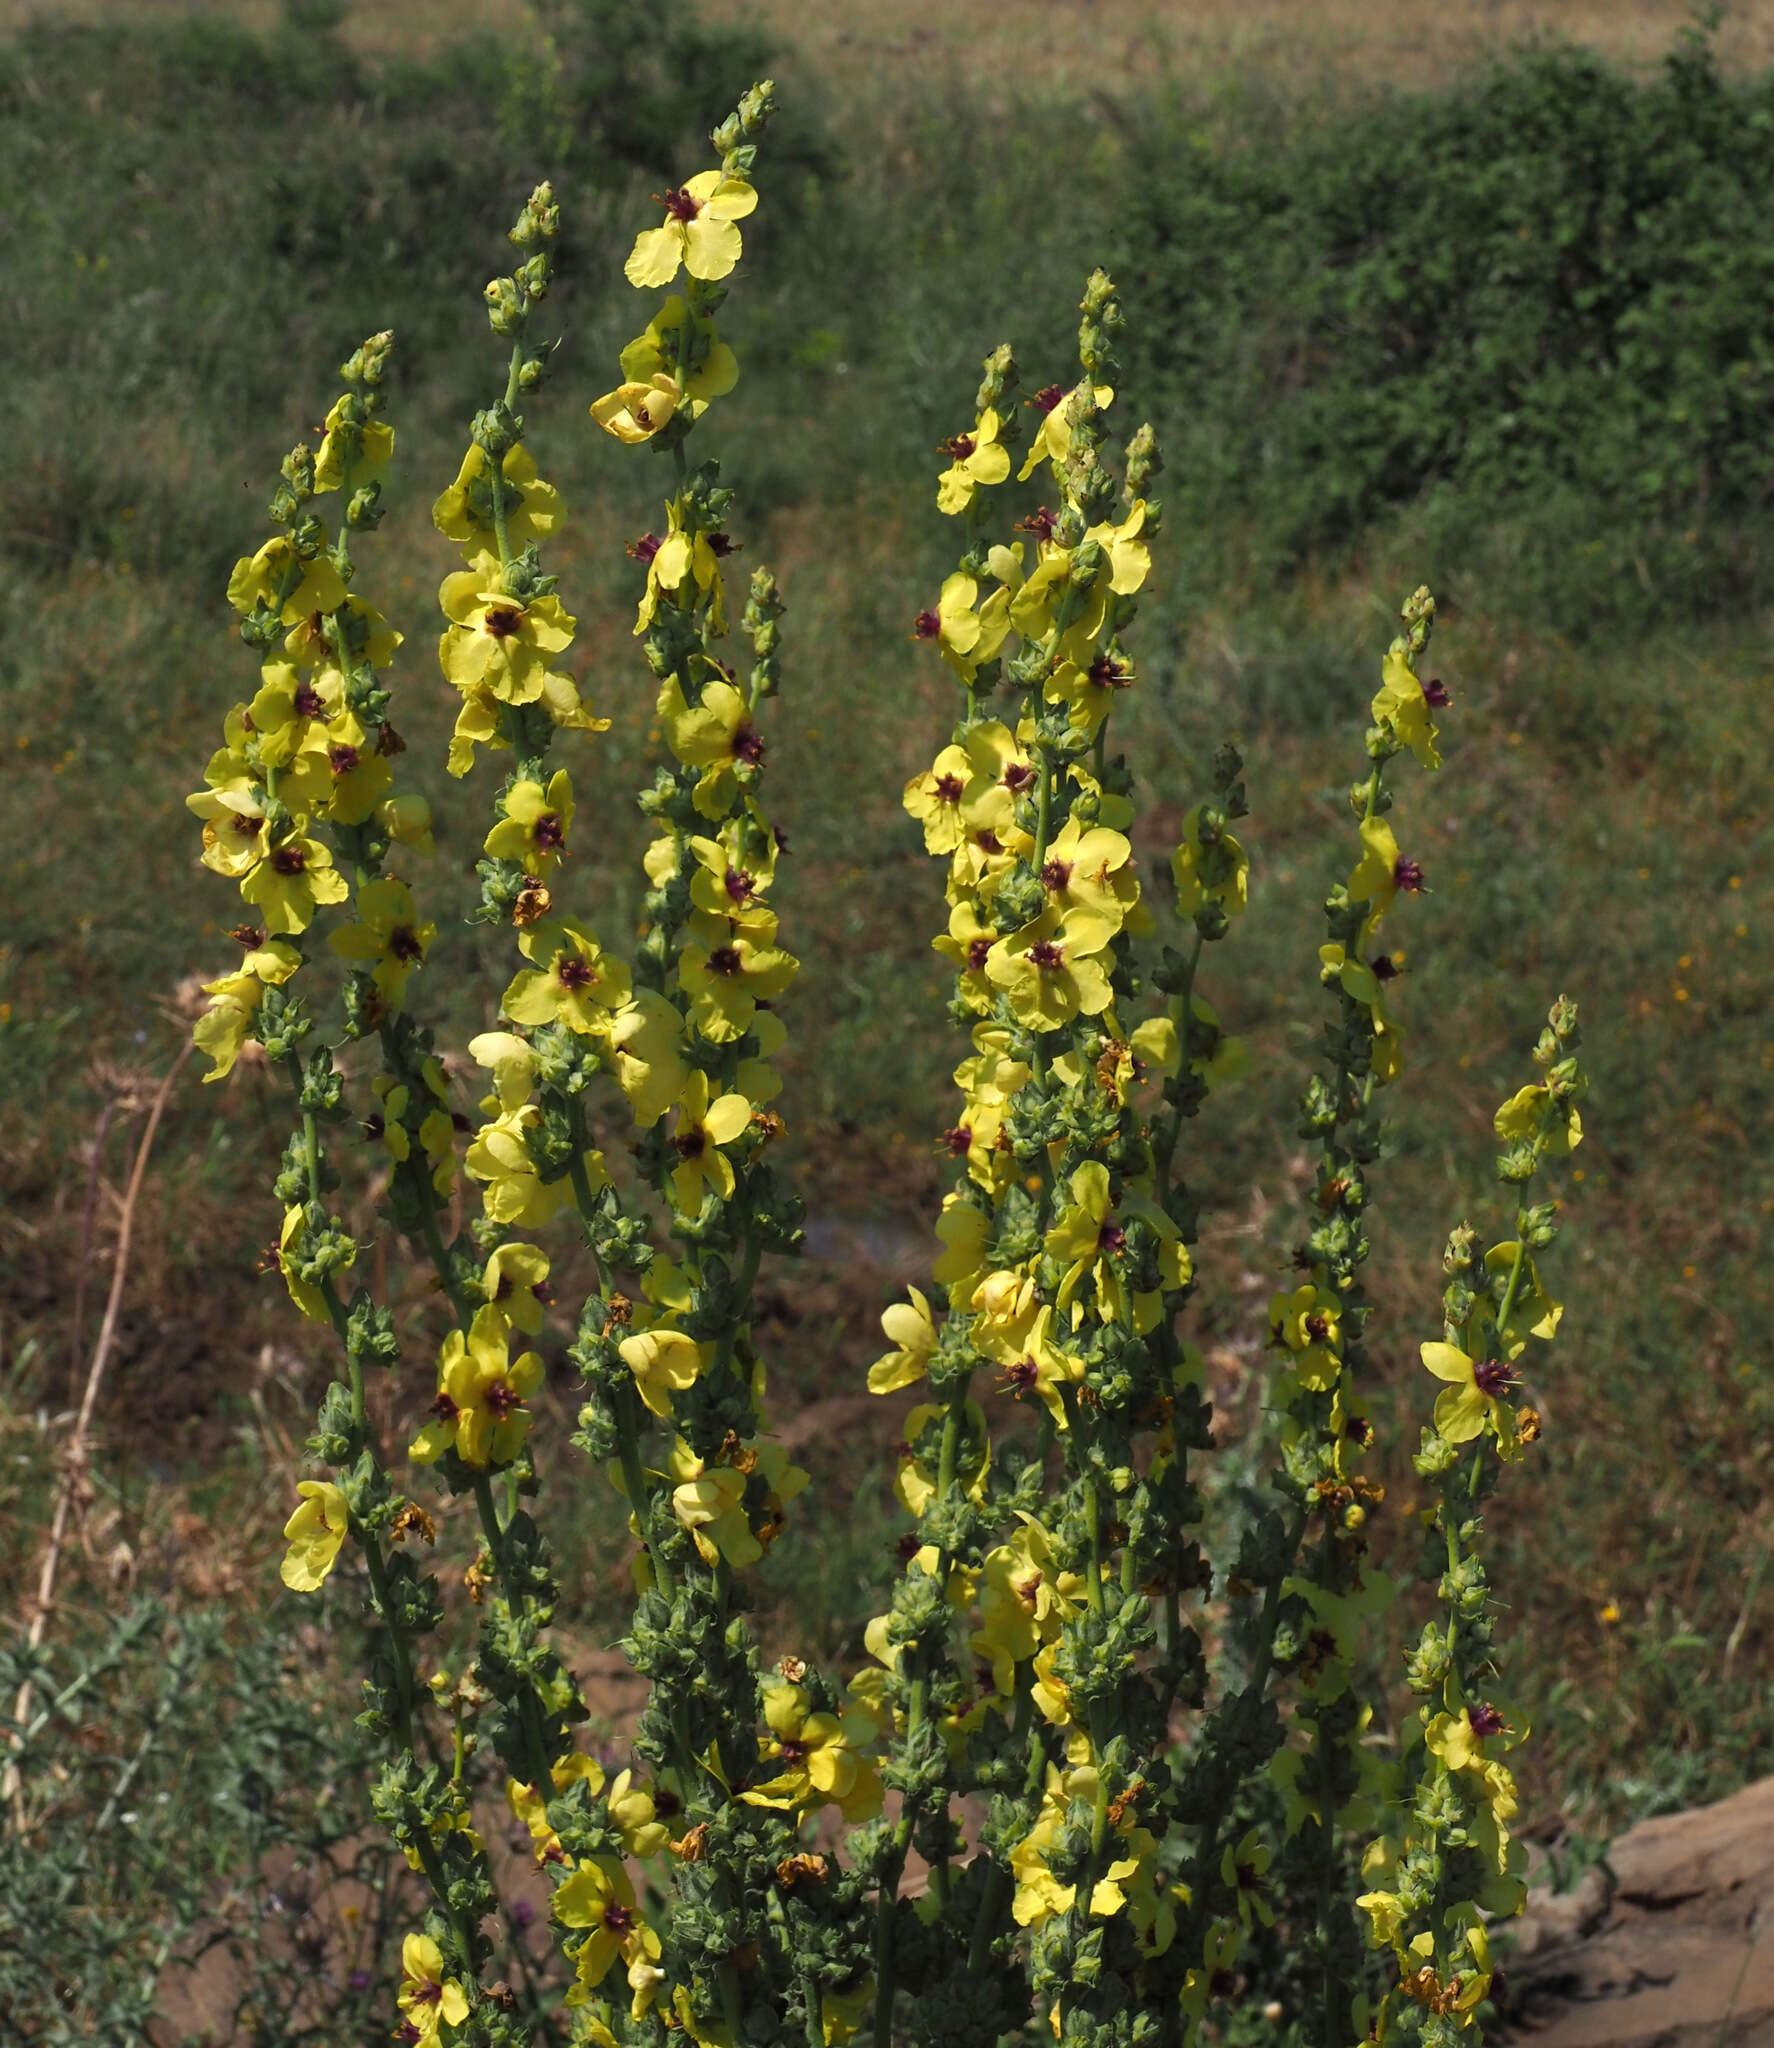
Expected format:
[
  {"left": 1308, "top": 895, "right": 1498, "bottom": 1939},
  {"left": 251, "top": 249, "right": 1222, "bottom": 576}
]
[{"left": 869, "top": 272, "right": 1245, "bottom": 2048}]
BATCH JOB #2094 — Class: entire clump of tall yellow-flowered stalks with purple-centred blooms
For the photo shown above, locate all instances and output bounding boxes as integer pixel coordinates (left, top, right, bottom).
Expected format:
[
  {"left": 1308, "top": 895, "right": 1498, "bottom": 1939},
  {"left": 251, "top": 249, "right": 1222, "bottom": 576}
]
[{"left": 191, "top": 82, "right": 1581, "bottom": 2048}]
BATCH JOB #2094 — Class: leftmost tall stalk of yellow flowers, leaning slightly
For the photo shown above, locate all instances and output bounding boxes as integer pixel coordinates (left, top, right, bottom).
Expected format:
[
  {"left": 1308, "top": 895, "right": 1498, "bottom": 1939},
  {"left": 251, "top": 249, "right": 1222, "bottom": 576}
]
[{"left": 188, "top": 334, "right": 548, "bottom": 2044}]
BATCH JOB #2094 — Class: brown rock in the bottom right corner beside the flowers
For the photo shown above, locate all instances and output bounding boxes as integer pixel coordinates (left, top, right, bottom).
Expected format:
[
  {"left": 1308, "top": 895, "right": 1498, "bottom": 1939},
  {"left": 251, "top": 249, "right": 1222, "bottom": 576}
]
[{"left": 1504, "top": 1778, "right": 1774, "bottom": 2048}]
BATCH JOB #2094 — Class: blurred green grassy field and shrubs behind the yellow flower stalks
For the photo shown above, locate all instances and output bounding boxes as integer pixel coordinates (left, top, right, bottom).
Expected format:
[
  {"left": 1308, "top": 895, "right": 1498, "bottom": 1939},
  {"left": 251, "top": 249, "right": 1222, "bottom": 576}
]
[{"left": 0, "top": 0, "right": 1774, "bottom": 2042}]
